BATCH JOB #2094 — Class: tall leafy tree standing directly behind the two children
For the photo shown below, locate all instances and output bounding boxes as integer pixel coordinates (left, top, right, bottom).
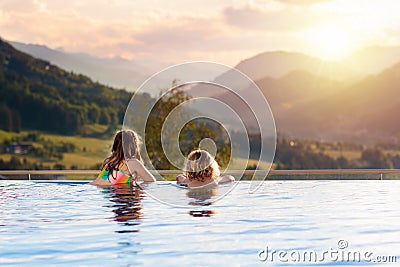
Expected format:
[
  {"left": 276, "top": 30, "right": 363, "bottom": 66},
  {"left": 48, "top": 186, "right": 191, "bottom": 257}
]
[{"left": 140, "top": 87, "right": 231, "bottom": 169}]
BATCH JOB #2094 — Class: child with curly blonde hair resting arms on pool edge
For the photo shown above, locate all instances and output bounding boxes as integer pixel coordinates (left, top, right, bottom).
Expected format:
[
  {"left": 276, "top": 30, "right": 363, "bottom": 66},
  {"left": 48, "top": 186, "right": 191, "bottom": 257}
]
[{"left": 176, "top": 149, "right": 235, "bottom": 188}]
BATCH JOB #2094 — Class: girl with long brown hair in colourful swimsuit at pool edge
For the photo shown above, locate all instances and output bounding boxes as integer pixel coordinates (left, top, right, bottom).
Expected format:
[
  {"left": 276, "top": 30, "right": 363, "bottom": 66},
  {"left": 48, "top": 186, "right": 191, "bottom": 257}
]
[{"left": 90, "top": 130, "right": 156, "bottom": 185}]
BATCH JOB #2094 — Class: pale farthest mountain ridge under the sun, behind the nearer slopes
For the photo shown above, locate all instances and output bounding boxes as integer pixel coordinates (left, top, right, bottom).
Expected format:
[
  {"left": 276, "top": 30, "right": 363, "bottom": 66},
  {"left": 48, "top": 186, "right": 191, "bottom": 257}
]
[{"left": 189, "top": 47, "right": 400, "bottom": 99}]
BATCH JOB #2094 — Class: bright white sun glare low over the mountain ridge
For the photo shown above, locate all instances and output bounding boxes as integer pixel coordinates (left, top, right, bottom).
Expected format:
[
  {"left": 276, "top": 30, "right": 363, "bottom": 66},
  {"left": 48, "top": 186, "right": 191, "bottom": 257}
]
[{"left": 309, "top": 27, "right": 350, "bottom": 60}]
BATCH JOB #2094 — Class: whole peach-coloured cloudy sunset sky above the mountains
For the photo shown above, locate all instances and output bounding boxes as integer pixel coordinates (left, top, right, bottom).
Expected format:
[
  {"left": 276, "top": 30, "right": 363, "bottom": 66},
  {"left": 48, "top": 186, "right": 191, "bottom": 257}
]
[{"left": 0, "top": 0, "right": 400, "bottom": 65}]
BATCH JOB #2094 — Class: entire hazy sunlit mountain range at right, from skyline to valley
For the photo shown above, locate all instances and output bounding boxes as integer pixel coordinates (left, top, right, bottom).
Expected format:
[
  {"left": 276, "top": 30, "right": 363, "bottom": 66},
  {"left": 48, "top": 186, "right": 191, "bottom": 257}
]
[{"left": 189, "top": 47, "right": 400, "bottom": 143}]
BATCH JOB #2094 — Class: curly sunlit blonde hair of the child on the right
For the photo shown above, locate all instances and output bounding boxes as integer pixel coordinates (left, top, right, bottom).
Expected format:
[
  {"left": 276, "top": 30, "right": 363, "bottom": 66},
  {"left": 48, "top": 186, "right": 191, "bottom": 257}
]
[{"left": 184, "top": 149, "right": 220, "bottom": 182}]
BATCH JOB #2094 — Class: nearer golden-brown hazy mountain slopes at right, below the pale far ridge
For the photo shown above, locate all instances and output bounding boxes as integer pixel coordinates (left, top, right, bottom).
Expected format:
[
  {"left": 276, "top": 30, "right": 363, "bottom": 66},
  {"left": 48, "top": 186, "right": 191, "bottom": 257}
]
[{"left": 197, "top": 57, "right": 400, "bottom": 144}]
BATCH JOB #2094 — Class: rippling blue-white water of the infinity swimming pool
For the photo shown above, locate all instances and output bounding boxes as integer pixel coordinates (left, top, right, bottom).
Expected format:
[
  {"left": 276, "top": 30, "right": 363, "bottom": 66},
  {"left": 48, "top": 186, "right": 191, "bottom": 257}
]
[{"left": 0, "top": 181, "right": 400, "bottom": 266}]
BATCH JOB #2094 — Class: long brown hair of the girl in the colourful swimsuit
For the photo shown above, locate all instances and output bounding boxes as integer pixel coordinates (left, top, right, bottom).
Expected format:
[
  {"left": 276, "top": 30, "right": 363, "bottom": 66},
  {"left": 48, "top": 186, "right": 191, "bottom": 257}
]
[{"left": 103, "top": 130, "right": 142, "bottom": 175}]
